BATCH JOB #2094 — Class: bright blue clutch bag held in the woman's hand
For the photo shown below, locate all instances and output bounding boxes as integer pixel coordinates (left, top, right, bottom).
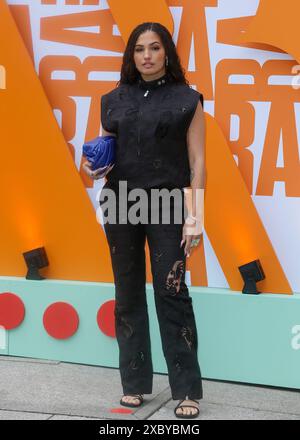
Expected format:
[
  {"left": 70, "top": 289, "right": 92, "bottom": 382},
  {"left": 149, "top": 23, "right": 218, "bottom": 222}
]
[{"left": 82, "top": 136, "right": 116, "bottom": 171}]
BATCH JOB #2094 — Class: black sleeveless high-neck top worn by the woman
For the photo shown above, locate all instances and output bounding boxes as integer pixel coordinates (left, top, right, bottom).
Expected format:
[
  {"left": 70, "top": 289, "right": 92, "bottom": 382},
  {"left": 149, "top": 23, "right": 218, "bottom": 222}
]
[{"left": 101, "top": 74, "right": 203, "bottom": 189}]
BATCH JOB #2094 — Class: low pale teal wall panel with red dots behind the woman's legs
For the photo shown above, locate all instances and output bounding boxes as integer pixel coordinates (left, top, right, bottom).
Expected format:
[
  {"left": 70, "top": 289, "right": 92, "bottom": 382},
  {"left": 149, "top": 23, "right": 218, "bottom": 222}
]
[{"left": 0, "top": 277, "right": 300, "bottom": 388}]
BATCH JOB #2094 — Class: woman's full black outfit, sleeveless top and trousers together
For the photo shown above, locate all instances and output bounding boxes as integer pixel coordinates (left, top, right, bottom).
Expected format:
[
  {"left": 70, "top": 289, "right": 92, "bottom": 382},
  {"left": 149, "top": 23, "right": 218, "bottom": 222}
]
[{"left": 100, "top": 74, "right": 203, "bottom": 399}]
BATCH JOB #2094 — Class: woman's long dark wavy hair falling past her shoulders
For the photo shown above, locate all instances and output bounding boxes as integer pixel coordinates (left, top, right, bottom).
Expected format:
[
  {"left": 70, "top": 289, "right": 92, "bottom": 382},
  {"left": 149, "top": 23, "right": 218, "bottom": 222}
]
[{"left": 117, "top": 22, "right": 189, "bottom": 86}]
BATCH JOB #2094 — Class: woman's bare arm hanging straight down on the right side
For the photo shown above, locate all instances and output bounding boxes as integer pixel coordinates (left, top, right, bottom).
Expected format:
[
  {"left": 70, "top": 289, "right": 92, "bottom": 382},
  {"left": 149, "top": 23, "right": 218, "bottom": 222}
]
[{"left": 181, "top": 101, "right": 206, "bottom": 257}]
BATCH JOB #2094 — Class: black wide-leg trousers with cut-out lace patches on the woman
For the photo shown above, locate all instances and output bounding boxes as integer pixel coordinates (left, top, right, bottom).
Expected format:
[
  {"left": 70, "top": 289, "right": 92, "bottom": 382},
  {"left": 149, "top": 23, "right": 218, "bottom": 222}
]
[{"left": 100, "top": 184, "right": 203, "bottom": 400}]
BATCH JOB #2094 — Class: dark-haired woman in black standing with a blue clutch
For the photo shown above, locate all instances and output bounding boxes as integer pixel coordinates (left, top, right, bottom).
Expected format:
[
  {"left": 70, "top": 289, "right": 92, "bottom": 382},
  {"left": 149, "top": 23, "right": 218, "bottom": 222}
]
[{"left": 84, "top": 23, "right": 205, "bottom": 418}]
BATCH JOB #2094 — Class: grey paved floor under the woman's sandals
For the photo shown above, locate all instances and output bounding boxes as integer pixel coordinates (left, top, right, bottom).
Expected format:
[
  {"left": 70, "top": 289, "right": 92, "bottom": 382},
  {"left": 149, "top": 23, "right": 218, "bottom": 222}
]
[{"left": 0, "top": 355, "right": 300, "bottom": 421}]
